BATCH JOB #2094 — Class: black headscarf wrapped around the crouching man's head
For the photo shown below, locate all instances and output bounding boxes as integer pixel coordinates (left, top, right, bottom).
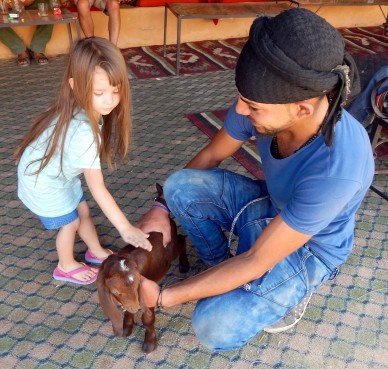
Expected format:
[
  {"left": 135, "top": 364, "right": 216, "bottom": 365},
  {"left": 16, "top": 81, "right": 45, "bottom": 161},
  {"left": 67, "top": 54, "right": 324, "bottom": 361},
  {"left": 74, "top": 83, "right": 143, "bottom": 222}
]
[{"left": 236, "top": 8, "right": 360, "bottom": 146}]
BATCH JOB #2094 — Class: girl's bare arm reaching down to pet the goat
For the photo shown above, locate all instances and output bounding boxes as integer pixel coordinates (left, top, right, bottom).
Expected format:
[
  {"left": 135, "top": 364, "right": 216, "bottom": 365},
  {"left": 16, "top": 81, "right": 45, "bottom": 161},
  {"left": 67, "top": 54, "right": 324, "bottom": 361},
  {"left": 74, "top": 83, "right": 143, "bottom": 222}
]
[{"left": 84, "top": 169, "right": 152, "bottom": 251}]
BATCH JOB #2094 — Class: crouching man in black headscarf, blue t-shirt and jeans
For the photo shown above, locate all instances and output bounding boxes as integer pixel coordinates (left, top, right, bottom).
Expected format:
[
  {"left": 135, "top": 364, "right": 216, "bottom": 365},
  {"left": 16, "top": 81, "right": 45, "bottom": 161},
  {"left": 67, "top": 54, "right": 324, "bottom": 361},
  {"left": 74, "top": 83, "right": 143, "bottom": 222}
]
[{"left": 140, "top": 8, "right": 374, "bottom": 350}]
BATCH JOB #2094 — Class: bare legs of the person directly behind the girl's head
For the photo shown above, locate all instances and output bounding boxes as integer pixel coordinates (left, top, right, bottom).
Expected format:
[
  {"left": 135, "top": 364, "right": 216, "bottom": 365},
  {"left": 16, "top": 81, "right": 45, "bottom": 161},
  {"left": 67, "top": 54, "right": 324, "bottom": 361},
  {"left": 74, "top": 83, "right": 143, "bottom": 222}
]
[{"left": 74, "top": 0, "right": 121, "bottom": 46}]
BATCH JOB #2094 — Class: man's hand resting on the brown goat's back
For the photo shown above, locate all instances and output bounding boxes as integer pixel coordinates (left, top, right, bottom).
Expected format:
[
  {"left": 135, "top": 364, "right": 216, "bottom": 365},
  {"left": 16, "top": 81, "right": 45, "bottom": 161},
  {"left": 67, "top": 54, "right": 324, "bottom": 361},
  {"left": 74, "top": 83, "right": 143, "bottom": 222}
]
[{"left": 138, "top": 208, "right": 171, "bottom": 246}]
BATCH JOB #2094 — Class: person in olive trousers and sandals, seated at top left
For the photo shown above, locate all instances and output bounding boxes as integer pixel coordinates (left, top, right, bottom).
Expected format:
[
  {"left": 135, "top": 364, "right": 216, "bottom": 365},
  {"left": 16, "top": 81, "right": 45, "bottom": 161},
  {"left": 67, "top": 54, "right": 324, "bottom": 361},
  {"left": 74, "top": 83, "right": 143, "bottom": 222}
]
[{"left": 0, "top": 0, "right": 54, "bottom": 67}]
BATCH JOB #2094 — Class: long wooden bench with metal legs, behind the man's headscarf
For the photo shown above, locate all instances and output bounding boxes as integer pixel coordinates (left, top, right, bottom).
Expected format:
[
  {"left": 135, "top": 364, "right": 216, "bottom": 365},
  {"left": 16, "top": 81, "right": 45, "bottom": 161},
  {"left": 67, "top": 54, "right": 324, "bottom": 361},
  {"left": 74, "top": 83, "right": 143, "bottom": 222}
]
[{"left": 163, "top": 1, "right": 298, "bottom": 76}]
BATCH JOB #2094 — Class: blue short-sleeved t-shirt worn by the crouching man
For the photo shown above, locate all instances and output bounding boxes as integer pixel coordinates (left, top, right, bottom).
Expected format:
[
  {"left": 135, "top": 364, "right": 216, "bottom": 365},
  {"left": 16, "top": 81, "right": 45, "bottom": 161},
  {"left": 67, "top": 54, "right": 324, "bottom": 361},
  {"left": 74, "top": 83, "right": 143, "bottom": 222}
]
[{"left": 224, "top": 104, "right": 374, "bottom": 266}]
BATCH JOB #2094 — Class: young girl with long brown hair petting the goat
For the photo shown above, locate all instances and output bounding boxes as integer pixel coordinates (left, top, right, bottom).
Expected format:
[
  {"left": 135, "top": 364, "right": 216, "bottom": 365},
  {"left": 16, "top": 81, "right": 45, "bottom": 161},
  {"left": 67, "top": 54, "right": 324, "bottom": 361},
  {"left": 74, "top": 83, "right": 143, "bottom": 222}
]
[{"left": 15, "top": 37, "right": 151, "bottom": 284}]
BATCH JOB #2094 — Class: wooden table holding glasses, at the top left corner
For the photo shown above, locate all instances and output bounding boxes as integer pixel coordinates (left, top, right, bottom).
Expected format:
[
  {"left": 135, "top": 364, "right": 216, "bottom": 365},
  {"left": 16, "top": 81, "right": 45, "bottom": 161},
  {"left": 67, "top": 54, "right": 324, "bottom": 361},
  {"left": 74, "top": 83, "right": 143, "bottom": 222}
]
[{"left": 0, "top": 9, "right": 81, "bottom": 45}]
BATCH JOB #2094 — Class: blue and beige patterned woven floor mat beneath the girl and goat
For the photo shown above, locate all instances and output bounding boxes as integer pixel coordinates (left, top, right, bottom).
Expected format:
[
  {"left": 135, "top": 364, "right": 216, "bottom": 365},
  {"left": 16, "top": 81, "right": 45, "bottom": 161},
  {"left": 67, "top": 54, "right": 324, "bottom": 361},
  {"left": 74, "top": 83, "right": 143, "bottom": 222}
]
[{"left": 0, "top": 56, "right": 388, "bottom": 369}]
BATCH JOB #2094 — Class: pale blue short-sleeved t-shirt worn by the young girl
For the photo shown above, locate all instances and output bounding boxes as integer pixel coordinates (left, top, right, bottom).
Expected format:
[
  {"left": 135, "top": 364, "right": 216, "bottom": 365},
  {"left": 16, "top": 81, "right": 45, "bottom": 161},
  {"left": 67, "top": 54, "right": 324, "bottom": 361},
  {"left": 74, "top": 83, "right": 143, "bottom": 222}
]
[{"left": 18, "top": 111, "right": 101, "bottom": 217}]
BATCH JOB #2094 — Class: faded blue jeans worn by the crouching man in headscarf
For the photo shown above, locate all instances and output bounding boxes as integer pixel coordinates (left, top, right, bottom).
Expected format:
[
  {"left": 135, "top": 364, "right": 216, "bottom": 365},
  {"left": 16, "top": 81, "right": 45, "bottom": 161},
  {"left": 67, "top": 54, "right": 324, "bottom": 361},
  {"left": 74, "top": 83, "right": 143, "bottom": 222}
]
[{"left": 164, "top": 168, "right": 336, "bottom": 350}]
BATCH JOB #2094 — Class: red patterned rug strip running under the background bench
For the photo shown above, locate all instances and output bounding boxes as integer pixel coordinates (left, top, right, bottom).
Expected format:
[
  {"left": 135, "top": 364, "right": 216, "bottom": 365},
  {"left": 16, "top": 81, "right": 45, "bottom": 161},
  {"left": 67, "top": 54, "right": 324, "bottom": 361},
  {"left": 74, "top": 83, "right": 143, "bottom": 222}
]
[{"left": 122, "top": 26, "right": 388, "bottom": 79}]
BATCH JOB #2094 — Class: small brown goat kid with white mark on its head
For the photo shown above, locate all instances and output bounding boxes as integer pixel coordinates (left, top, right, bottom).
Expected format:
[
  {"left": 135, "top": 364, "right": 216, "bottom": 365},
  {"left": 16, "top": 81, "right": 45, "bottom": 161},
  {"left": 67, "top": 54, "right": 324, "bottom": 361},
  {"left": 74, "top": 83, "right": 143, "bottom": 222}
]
[{"left": 97, "top": 219, "right": 189, "bottom": 353}]
